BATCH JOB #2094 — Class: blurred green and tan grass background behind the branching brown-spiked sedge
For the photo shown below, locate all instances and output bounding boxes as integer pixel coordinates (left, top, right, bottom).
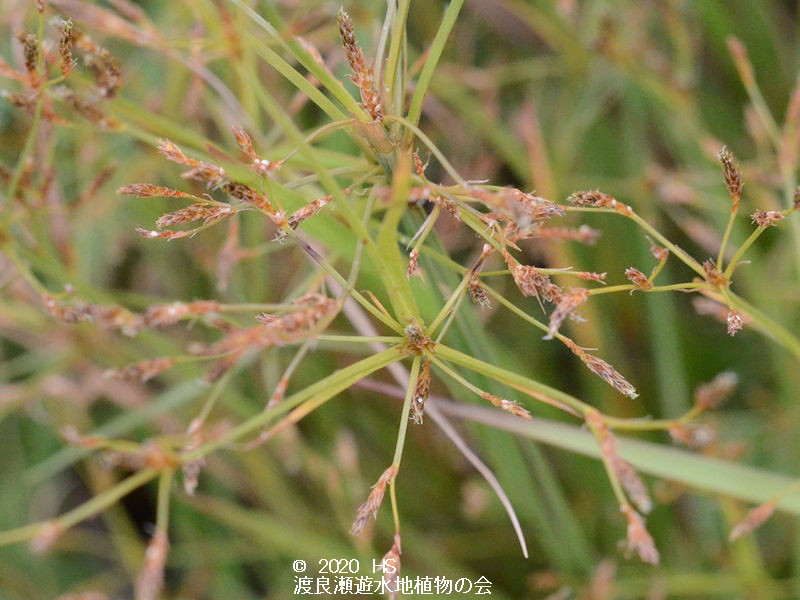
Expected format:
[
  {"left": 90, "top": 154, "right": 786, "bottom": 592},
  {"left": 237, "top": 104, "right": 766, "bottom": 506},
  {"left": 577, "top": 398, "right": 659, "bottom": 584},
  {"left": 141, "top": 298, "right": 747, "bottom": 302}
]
[{"left": 0, "top": 0, "right": 800, "bottom": 599}]
